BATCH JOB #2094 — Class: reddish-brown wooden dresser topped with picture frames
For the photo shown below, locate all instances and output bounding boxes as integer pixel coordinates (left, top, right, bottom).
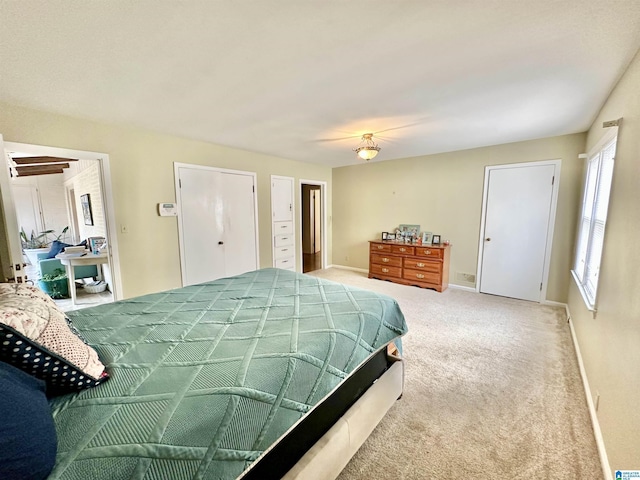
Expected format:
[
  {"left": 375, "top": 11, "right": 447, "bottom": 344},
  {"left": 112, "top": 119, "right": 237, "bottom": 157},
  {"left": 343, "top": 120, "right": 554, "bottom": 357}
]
[{"left": 369, "top": 241, "right": 450, "bottom": 292}]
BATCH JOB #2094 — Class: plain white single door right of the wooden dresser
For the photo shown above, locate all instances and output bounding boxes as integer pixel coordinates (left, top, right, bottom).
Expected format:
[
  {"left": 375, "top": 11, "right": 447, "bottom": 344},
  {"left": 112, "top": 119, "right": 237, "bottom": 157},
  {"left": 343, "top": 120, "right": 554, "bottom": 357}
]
[{"left": 480, "top": 163, "right": 556, "bottom": 301}]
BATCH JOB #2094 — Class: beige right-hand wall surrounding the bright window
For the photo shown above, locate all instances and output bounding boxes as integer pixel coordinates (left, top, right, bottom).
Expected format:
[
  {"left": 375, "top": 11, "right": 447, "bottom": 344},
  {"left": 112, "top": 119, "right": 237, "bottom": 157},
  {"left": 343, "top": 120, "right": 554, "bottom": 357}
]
[{"left": 569, "top": 47, "right": 640, "bottom": 470}]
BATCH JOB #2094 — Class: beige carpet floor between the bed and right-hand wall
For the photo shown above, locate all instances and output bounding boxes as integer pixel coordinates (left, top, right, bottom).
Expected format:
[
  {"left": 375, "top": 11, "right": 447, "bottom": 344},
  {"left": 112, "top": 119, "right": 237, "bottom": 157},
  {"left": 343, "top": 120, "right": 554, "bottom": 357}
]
[{"left": 312, "top": 269, "right": 603, "bottom": 480}]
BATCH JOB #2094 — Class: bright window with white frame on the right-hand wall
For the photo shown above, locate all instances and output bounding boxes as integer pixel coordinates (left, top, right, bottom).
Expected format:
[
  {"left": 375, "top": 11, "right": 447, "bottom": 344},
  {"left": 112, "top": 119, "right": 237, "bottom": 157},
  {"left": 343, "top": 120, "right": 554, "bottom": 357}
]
[{"left": 572, "top": 136, "right": 617, "bottom": 311}]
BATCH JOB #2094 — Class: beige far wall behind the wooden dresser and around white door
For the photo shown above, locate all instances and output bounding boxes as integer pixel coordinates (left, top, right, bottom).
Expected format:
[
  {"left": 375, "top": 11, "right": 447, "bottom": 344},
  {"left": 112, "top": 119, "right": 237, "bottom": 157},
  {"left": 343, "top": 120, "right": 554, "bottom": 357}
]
[{"left": 333, "top": 134, "right": 585, "bottom": 302}]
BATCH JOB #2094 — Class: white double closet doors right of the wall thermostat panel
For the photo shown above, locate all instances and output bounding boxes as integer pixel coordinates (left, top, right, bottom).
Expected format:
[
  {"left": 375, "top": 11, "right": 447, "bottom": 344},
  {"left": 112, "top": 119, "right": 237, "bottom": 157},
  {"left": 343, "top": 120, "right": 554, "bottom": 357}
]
[{"left": 176, "top": 166, "right": 258, "bottom": 285}]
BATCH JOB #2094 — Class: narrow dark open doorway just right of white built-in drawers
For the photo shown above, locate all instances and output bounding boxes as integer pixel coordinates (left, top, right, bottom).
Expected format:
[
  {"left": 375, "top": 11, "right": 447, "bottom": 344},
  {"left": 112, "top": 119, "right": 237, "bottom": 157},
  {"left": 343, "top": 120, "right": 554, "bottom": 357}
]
[{"left": 300, "top": 182, "right": 324, "bottom": 273}]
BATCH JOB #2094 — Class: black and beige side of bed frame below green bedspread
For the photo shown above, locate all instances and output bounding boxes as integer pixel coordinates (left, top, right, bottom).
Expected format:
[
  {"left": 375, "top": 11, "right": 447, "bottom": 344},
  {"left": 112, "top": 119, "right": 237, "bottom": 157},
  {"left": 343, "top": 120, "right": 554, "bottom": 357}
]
[{"left": 238, "top": 343, "right": 404, "bottom": 480}]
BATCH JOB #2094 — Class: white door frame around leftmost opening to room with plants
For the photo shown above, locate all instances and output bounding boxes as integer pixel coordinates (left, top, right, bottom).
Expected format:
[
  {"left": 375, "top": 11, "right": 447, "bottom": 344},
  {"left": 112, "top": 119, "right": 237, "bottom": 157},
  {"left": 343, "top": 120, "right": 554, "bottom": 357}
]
[{"left": 0, "top": 134, "right": 123, "bottom": 300}]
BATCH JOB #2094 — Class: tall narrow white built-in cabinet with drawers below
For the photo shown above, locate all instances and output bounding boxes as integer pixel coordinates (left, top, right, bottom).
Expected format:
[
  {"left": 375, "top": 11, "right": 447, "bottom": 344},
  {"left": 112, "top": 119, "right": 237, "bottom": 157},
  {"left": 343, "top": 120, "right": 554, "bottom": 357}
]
[{"left": 271, "top": 175, "right": 296, "bottom": 271}]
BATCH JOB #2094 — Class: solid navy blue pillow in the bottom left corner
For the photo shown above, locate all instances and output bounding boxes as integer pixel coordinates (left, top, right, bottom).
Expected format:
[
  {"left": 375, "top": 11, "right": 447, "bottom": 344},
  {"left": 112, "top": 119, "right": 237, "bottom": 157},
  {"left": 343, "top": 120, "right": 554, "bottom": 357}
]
[{"left": 0, "top": 362, "right": 57, "bottom": 480}]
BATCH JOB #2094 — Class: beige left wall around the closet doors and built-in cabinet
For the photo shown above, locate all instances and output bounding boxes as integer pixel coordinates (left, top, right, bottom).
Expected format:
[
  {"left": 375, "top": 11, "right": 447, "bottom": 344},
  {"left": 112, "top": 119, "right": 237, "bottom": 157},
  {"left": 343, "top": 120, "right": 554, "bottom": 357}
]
[{"left": 0, "top": 104, "right": 331, "bottom": 297}]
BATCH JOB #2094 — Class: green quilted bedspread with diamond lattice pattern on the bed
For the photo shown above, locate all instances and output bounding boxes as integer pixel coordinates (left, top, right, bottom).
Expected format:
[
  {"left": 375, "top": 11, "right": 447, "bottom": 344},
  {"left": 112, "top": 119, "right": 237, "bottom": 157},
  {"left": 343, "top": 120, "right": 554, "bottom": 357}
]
[{"left": 50, "top": 269, "right": 407, "bottom": 480}]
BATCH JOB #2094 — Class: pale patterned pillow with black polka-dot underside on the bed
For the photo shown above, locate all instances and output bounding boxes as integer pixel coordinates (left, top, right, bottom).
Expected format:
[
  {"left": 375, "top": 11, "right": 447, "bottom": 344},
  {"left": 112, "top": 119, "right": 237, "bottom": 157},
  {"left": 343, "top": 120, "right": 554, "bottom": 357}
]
[{"left": 0, "top": 283, "right": 109, "bottom": 395}]
